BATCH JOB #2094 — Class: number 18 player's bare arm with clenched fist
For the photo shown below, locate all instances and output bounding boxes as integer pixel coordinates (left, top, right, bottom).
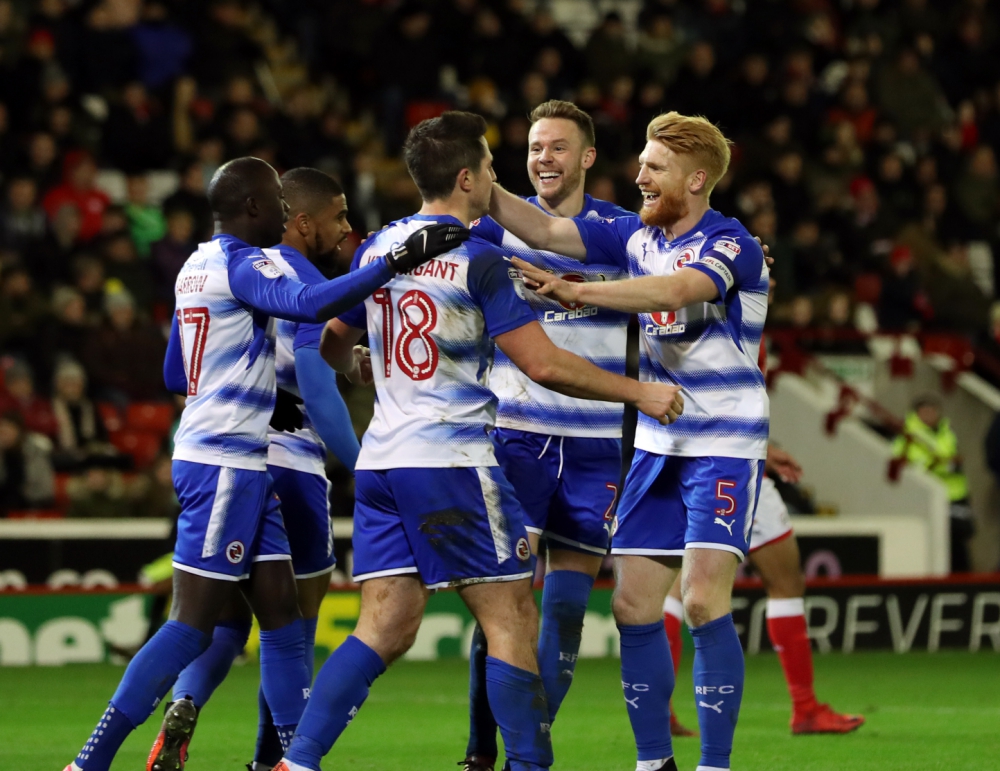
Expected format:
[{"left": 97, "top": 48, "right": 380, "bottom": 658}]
[{"left": 495, "top": 321, "right": 684, "bottom": 425}]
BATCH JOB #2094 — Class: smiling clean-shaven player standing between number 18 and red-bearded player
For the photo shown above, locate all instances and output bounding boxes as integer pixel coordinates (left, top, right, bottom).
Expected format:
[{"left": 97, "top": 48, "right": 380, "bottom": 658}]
[{"left": 464, "top": 100, "right": 628, "bottom": 771}]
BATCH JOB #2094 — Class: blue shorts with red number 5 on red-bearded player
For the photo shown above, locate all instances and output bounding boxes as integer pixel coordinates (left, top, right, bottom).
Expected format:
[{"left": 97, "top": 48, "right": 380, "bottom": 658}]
[{"left": 611, "top": 450, "right": 764, "bottom": 560}]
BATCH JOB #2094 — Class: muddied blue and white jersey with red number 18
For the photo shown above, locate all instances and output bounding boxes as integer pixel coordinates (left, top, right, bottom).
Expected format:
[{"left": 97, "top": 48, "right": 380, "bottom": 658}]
[{"left": 340, "top": 214, "right": 535, "bottom": 470}]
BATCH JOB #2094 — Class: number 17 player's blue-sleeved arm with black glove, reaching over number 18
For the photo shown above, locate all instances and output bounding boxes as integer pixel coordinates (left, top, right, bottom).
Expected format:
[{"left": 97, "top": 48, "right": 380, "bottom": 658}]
[{"left": 229, "top": 223, "right": 469, "bottom": 322}]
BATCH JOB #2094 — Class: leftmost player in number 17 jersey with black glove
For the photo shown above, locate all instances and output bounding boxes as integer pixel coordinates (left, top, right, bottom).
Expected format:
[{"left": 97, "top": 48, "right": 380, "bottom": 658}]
[{"left": 67, "top": 158, "right": 468, "bottom": 771}]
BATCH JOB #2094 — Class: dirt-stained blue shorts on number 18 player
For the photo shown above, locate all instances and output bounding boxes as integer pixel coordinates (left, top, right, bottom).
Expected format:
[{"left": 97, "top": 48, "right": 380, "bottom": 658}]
[{"left": 354, "top": 466, "right": 532, "bottom": 589}]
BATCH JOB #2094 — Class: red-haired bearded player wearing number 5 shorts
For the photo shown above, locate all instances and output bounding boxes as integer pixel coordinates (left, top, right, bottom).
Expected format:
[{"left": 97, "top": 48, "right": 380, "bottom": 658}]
[{"left": 490, "top": 113, "right": 768, "bottom": 771}]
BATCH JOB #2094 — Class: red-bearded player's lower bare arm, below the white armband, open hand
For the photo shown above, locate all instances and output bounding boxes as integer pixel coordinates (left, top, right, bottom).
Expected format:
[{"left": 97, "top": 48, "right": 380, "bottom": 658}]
[{"left": 511, "top": 257, "right": 719, "bottom": 313}]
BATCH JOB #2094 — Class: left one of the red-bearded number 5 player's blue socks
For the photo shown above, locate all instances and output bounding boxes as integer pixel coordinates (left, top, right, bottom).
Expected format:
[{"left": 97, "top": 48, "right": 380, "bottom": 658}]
[{"left": 618, "top": 621, "right": 674, "bottom": 760}]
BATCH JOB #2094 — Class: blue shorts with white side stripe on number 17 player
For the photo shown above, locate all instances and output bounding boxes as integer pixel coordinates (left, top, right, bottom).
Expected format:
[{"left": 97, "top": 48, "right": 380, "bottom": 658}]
[{"left": 173, "top": 460, "right": 291, "bottom": 581}]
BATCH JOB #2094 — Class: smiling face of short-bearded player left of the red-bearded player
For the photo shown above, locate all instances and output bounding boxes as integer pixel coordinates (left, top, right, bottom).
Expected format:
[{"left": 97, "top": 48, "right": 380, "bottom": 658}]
[{"left": 528, "top": 118, "right": 595, "bottom": 206}]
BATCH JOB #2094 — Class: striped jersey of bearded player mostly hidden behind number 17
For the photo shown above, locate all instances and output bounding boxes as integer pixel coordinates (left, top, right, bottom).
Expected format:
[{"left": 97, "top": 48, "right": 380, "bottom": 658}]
[{"left": 264, "top": 244, "right": 326, "bottom": 477}]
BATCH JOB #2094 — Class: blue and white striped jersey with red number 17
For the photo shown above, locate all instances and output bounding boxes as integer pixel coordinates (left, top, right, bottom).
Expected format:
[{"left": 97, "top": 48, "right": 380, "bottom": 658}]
[{"left": 164, "top": 234, "right": 394, "bottom": 471}]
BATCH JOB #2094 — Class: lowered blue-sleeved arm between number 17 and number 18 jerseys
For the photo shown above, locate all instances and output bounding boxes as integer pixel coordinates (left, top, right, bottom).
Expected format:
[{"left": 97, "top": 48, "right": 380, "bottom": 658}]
[{"left": 295, "top": 347, "right": 361, "bottom": 472}]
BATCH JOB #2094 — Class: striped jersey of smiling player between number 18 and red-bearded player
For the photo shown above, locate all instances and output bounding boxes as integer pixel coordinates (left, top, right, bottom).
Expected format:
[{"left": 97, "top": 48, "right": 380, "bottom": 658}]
[{"left": 472, "top": 195, "right": 629, "bottom": 439}]
